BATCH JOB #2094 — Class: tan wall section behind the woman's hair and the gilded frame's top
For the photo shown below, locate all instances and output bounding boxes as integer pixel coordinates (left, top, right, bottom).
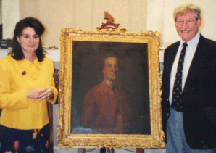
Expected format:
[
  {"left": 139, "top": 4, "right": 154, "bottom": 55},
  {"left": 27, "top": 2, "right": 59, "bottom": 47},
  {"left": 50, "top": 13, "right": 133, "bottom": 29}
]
[{"left": 8, "top": 0, "right": 147, "bottom": 47}]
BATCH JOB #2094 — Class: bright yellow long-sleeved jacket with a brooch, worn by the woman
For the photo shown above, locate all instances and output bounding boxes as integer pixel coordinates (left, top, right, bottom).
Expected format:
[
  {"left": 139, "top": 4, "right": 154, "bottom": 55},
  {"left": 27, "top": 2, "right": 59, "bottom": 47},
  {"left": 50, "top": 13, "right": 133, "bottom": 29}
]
[{"left": 0, "top": 55, "right": 58, "bottom": 129}]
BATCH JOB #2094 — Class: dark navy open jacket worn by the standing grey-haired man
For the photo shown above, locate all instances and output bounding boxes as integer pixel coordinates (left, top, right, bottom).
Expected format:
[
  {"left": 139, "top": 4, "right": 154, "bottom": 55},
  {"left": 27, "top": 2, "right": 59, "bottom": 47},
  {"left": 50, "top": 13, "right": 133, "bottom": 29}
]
[{"left": 162, "top": 36, "right": 216, "bottom": 149}]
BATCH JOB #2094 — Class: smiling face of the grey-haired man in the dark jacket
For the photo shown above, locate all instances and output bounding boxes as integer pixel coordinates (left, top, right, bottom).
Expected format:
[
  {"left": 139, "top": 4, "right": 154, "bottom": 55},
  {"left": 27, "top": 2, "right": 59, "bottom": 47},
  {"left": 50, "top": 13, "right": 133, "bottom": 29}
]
[{"left": 175, "top": 11, "right": 201, "bottom": 42}]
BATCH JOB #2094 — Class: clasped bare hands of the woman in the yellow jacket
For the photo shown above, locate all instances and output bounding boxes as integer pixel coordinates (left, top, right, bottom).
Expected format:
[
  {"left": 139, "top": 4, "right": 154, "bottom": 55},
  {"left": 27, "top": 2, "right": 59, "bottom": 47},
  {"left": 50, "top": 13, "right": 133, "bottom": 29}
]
[{"left": 26, "top": 87, "right": 54, "bottom": 101}]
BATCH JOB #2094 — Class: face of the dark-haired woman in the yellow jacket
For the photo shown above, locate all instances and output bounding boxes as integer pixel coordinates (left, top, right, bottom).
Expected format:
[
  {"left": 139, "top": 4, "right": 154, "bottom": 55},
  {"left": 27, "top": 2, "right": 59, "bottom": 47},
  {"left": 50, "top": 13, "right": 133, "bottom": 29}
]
[{"left": 17, "top": 27, "right": 40, "bottom": 54}]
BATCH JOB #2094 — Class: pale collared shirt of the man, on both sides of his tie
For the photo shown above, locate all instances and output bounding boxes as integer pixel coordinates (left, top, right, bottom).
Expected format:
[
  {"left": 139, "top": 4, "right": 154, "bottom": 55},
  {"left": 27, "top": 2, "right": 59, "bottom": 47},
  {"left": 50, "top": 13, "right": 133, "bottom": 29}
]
[{"left": 169, "top": 32, "right": 200, "bottom": 104}]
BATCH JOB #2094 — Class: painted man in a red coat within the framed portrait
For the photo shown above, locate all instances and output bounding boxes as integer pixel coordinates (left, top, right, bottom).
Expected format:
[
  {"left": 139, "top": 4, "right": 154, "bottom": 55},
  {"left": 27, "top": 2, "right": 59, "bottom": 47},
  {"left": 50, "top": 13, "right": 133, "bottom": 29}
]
[{"left": 81, "top": 57, "right": 130, "bottom": 134}]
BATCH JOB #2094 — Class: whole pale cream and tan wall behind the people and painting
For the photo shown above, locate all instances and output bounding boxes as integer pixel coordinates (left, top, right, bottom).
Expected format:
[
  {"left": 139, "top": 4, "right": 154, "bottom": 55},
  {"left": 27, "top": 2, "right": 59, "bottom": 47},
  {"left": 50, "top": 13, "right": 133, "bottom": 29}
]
[{"left": 2, "top": 0, "right": 216, "bottom": 47}]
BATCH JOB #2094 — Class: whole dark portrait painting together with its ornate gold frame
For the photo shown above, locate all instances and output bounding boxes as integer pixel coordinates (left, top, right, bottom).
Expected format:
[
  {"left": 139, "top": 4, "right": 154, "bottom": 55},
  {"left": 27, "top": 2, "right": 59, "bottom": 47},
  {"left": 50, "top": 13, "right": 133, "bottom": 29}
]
[{"left": 57, "top": 28, "right": 165, "bottom": 149}]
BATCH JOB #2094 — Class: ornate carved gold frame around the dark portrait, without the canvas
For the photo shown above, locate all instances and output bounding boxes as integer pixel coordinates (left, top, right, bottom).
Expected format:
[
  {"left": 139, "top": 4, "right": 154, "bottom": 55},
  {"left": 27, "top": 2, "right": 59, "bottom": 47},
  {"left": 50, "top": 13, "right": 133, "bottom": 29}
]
[{"left": 57, "top": 28, "right": 165, "bottom": 149}]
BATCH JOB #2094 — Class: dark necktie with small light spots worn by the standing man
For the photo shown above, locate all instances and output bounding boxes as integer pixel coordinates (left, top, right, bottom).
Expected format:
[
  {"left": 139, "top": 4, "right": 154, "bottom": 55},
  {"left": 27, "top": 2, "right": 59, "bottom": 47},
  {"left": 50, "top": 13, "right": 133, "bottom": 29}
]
[{"left": 172, "top": 43, "right": 187, "bottom": 112}]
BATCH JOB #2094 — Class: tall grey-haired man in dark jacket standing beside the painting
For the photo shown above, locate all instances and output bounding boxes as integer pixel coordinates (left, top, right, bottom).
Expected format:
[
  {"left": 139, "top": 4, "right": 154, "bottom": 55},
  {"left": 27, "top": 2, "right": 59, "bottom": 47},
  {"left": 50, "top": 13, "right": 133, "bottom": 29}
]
[{"left": 162, "top": 4, "right": 216, "bottom": 153}]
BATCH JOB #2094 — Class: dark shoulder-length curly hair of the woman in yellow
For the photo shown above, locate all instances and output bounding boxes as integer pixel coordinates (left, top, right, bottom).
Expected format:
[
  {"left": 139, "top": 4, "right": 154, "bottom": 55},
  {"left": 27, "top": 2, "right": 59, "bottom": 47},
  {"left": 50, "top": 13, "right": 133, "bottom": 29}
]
[{"left": 11, "top": 17, "right": 45, "bottom": 62}]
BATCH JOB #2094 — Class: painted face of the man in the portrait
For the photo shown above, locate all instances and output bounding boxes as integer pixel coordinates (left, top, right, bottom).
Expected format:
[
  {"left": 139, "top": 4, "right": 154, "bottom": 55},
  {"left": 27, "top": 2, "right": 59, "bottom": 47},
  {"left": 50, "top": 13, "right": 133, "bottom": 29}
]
[{"left": 103, "top": 57, "right": 118, "bottom": 81}]
